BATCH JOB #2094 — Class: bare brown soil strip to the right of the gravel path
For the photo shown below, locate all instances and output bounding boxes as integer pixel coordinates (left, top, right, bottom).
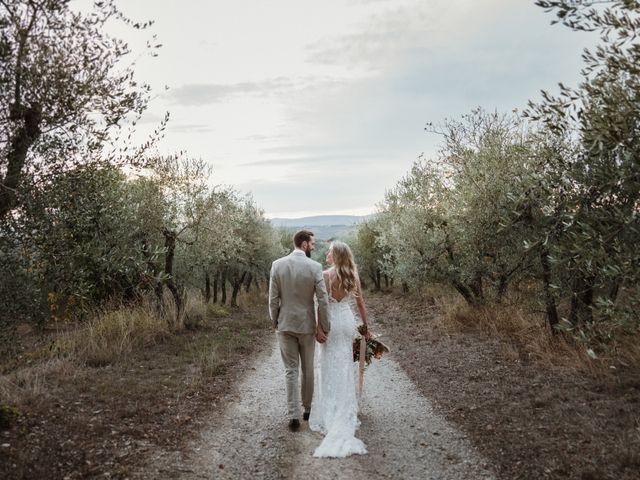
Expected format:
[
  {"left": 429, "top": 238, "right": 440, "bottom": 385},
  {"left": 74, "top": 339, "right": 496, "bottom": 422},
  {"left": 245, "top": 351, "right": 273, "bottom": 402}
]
[{"left": 367, "top": 293, "right": 640, "bottom": 480}]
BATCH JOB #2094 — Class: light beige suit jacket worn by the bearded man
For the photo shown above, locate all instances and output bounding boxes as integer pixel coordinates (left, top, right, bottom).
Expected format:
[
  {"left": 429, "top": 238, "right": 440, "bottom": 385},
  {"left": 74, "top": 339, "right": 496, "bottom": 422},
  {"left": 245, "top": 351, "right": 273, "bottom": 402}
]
[{"left": 269, "top": 250, "right": 331, "bottom": 333}]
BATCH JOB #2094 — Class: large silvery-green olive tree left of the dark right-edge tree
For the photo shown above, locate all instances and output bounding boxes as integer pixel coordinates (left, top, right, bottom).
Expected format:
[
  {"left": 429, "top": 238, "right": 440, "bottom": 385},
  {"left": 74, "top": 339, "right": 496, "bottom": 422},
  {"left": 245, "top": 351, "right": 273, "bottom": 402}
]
[{"left": 376, "top": 110, "right": 533, "bottom": 304}]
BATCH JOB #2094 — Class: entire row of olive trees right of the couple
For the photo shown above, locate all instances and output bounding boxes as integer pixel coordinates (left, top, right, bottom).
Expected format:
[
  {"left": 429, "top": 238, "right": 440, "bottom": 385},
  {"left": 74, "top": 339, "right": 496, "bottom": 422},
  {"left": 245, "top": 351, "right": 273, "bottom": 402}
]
[{"left": 355, "top": 0, "right": 640, "bottom": 345}]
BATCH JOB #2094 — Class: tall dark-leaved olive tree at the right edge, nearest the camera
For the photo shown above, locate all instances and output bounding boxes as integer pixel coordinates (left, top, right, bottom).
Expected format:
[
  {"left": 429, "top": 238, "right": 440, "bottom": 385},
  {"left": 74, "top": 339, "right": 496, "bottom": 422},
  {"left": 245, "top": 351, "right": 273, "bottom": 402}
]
[{"left": 527, "top": 0, "right": 640, "bottom": 335}]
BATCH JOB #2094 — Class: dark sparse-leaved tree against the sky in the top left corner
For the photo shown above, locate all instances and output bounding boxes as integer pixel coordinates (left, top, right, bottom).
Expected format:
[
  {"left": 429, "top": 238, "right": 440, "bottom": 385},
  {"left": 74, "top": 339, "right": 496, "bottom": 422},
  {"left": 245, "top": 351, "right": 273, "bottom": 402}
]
[{"left": 0, "top": 0, "right": 162, "bottom": 218}]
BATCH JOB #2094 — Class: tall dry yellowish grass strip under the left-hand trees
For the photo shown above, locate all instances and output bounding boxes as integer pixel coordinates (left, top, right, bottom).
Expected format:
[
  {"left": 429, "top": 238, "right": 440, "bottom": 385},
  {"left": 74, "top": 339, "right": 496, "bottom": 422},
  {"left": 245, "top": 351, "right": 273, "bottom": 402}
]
[{"left": 0, "top": 292, "right": 269, "bottom": 416}]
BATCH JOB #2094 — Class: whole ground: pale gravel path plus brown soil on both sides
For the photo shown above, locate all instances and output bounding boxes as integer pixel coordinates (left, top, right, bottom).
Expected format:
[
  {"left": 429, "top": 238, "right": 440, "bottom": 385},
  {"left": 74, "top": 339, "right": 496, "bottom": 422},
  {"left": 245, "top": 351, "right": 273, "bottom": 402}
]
[{"left": 0, "top": 294, "right": 640, "bottom": 480}]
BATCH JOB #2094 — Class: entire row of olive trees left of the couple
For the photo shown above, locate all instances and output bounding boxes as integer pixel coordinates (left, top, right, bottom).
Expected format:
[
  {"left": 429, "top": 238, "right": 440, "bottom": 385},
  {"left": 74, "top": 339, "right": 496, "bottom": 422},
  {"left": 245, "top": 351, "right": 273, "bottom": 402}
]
[{"left": 0, "top": 0, "right": 282, "bottom": 338}]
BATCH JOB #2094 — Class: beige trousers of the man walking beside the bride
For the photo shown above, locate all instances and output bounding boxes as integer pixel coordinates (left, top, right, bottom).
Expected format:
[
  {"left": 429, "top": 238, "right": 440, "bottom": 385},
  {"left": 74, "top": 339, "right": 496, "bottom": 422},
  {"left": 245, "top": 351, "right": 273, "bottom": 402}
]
[{"left": 276, "top": 332, "right": 315, "bottom": 419}]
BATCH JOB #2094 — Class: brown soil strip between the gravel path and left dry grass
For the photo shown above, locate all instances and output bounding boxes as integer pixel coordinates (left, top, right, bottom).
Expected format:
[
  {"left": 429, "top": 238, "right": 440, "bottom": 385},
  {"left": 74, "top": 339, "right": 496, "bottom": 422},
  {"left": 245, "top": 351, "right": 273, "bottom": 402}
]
[{"left": 0, "top": 305, "right": 270, "bottom": 479}]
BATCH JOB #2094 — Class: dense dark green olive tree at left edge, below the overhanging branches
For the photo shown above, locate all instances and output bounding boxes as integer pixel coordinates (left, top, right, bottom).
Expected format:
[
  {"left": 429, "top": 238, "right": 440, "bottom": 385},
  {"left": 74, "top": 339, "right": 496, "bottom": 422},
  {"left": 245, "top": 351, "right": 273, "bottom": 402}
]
[{"left": 0, "top": 165, "right": 165, "bottom": 321}]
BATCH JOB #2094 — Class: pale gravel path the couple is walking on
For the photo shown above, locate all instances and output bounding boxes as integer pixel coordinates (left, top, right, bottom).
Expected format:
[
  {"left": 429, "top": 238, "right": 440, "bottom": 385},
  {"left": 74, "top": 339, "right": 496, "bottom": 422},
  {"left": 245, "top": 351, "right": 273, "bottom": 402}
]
[{"left": 152, "top": 340, "right": 493, "bottom": 479}]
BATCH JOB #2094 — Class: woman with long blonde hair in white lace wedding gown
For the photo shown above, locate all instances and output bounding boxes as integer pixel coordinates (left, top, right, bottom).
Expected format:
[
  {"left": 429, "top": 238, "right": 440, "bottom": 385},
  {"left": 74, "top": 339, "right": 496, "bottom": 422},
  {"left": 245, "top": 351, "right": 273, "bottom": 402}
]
[{"left": 309, "top": 241, "right": 369, "bottom": 457}]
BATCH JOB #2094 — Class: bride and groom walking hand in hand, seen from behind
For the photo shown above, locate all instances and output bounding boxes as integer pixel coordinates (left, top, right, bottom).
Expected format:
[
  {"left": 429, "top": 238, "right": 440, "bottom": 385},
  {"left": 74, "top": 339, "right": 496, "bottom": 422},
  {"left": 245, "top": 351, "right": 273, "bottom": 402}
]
[{"left": 269, "top": 230, "right": 368, "bottom": 457}]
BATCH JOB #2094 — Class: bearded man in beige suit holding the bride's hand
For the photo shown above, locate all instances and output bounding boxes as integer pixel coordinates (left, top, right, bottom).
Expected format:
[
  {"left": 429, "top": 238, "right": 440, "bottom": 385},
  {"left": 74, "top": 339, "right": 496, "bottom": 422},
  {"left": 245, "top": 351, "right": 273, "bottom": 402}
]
[{"left": 269, "top": 230, "right": 330, "bottom": 431}]
